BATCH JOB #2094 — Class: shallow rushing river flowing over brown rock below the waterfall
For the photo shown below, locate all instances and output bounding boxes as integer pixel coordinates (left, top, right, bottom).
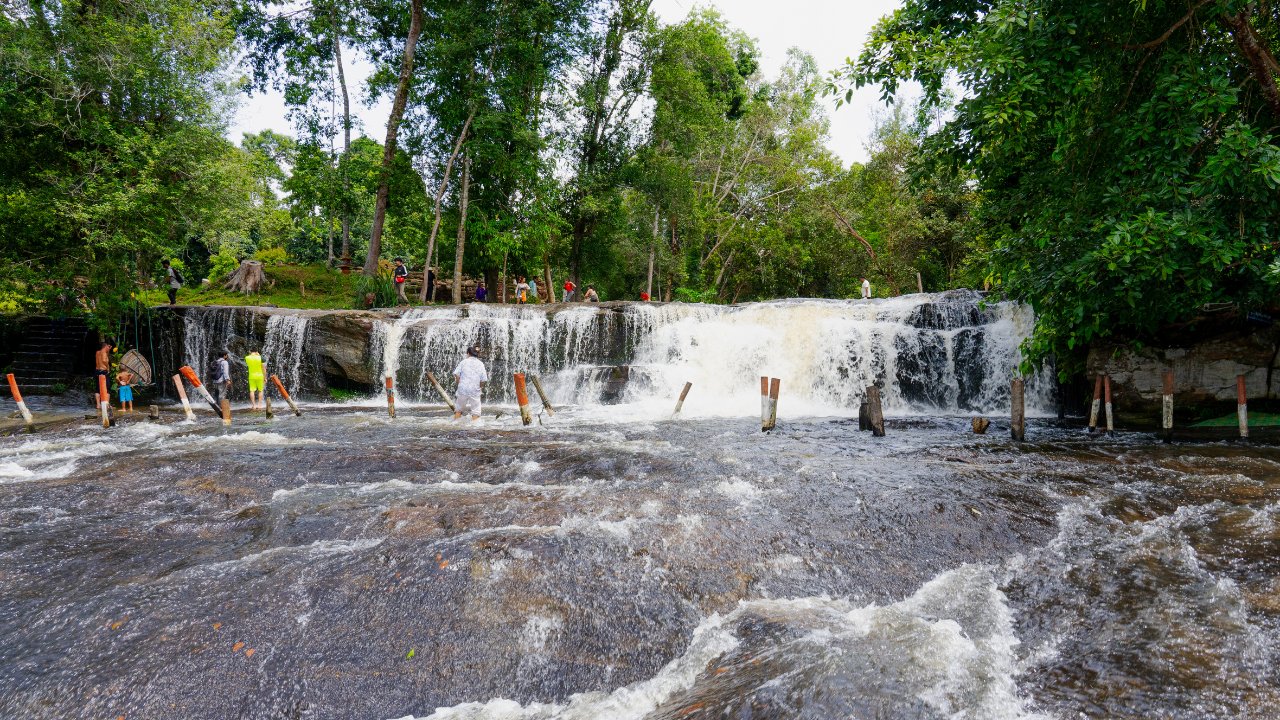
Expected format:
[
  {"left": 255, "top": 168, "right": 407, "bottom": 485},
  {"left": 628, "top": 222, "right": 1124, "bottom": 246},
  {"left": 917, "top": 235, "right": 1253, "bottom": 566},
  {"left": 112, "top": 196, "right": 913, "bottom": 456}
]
[{"left": 0, "top": 402, "right": 1280, "bottom": 719}]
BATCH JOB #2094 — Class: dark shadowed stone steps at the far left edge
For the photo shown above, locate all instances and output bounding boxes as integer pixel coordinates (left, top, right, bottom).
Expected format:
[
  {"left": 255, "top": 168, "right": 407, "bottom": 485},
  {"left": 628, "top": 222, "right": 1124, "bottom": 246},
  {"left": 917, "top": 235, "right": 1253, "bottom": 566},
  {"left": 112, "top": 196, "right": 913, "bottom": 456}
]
[{"left": 0, "top": 318, "right": 92, "bottom": 396}]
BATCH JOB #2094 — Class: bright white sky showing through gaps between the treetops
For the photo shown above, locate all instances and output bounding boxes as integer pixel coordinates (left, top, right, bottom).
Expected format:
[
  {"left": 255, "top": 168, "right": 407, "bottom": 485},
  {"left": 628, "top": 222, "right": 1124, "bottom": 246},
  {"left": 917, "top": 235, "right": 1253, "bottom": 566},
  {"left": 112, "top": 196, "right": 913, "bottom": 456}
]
[{"left": 228, "top": 0, "right": 901, "bottom": 164}]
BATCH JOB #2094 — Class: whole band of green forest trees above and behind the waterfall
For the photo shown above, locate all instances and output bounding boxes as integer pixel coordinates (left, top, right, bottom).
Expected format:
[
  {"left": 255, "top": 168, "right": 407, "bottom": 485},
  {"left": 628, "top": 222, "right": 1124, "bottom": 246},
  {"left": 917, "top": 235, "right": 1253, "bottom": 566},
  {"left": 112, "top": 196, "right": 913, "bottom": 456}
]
[{"left": 0, "top": 0, "right": 1280, "bottom": 361}]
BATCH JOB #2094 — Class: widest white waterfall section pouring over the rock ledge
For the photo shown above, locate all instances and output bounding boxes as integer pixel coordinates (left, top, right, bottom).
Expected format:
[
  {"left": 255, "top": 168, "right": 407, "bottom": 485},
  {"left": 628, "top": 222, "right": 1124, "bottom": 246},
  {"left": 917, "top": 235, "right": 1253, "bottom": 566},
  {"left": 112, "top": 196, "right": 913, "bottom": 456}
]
[{"left": 371, "top": 292, "right": 1052, "bottom": 415}]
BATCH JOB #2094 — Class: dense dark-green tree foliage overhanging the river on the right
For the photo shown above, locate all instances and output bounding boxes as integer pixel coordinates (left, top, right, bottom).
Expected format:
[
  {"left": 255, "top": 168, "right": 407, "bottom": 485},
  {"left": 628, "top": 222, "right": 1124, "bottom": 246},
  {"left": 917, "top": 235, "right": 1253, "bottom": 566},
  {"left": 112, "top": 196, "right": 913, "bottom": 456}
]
[{"left": 836, "top": 0, "right": 1280, "bottom": 370}]
